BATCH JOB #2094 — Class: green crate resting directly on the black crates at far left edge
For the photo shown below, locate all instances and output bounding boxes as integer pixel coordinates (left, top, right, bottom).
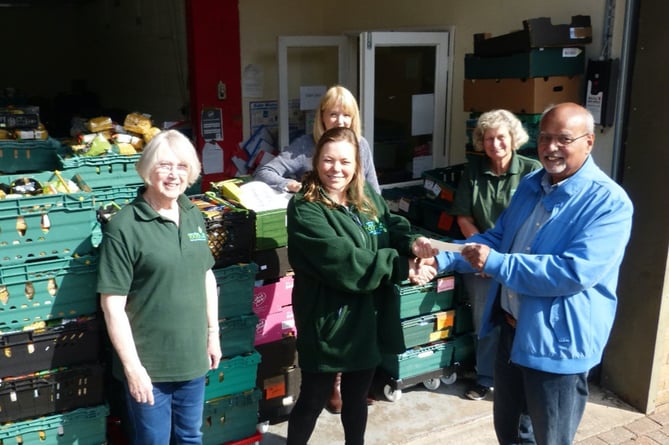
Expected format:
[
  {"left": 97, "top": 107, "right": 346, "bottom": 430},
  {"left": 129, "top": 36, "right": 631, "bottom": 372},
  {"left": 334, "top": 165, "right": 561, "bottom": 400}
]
[{"left": 0, "top": 255, "right": 98, "bottom": 332}]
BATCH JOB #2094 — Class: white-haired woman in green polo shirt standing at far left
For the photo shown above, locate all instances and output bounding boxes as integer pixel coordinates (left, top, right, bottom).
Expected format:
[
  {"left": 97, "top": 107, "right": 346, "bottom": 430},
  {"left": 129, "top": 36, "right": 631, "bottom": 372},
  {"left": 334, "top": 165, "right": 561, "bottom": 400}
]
[{"left": 97, "top": 130, "right": 221, "bottom": 445}]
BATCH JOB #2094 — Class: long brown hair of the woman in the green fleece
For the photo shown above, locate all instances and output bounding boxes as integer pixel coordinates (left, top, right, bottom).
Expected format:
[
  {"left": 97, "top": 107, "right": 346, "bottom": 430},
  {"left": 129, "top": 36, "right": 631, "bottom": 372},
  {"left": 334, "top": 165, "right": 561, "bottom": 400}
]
[{"left": 303, "top": 127, "right": 378, "bottom": 218}]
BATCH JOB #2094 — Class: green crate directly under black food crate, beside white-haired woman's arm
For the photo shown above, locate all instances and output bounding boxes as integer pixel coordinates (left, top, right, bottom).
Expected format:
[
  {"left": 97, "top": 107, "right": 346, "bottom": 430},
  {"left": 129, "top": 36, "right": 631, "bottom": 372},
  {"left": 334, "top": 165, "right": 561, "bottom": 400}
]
[{"left": 214, "top": 263, "right": 258, "bottom": 319}]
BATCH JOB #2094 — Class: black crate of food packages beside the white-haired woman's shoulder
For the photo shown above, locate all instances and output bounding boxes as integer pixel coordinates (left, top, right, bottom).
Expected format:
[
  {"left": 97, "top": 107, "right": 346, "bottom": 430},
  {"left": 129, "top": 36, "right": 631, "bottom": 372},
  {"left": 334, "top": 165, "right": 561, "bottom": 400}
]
[{"left": 190, "top": 192, "right": 255, "bottom": 267}]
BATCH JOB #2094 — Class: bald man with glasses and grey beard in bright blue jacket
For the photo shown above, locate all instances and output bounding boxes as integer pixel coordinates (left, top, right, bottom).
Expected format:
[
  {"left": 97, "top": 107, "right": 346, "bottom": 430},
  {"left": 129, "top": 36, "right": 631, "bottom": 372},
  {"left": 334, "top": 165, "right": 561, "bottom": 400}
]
[{"left": 428, "top": 103, "right": 633, "bottom": 445}]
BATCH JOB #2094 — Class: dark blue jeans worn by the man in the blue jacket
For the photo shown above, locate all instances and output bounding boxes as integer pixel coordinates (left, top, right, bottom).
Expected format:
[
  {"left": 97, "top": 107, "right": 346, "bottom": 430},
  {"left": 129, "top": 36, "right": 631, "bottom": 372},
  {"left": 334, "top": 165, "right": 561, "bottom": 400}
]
[{"left": 493, "top": 323, "right": 588, "bottom": 445}]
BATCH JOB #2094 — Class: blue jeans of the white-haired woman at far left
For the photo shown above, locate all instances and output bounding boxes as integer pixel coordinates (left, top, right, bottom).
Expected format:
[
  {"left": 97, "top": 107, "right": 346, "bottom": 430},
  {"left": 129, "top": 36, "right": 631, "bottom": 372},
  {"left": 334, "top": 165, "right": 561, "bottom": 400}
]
[{"left": 125, "top": 376, "right": 204, "bottom": 445}]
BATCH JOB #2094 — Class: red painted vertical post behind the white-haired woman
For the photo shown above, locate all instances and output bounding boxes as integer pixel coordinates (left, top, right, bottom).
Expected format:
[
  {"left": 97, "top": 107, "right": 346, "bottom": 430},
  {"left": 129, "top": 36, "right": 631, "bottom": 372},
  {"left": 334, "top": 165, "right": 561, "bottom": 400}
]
[{"left": 185, "top": 0, "right": 245, "bottom": 191}]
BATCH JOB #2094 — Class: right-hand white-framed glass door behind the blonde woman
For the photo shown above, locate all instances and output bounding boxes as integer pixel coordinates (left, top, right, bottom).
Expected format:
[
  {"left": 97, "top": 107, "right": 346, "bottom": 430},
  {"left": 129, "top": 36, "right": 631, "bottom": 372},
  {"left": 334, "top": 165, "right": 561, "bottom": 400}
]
[{"left": 359, "top": 31, "right": 453, "bottom": 185}]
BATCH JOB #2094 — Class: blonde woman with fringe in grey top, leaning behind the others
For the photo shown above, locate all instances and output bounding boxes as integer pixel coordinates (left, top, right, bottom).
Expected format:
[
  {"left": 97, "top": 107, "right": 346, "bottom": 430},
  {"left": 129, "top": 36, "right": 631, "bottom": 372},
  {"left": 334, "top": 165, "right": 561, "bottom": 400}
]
[{"left": 253, "top": 85, "right": 380, "bottom": 193}]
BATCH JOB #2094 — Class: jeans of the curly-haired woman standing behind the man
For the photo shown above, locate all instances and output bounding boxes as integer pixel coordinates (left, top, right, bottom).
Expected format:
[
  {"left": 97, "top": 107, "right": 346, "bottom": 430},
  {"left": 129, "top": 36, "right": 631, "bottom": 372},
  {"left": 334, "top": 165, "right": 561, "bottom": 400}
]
[{"left": 462, "top": 273, "right": 499, "bottom": 387}]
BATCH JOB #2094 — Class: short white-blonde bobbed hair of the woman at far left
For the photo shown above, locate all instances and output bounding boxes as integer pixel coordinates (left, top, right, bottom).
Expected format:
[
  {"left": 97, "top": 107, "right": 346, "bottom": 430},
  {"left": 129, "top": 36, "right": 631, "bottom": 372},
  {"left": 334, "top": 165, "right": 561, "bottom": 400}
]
[{"left": 135, "top": 130, "right": 202, "bottom": 185}]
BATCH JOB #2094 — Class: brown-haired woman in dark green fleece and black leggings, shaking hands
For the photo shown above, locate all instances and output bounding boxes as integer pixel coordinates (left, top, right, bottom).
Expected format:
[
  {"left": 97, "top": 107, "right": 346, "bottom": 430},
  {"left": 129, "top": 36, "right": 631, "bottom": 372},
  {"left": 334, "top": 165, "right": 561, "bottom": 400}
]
[{"left": 287, "top": 127, "right": 436, "bottom": 445}]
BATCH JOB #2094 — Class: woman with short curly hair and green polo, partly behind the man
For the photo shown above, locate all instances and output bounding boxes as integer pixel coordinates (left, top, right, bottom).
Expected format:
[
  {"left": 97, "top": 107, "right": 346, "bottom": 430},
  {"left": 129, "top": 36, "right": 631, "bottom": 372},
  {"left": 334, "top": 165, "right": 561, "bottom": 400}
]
[{"left": 451, "top": 110, "right": 541, "bottom": 400}]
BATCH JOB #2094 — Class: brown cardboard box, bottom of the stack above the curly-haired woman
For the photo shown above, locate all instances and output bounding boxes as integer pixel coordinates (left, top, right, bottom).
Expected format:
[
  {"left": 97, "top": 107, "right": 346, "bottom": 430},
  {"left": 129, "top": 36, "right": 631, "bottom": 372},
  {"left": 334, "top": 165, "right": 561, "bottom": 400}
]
[{"left": 463, "top": 76, "right": 582, "bottom": 114}]
